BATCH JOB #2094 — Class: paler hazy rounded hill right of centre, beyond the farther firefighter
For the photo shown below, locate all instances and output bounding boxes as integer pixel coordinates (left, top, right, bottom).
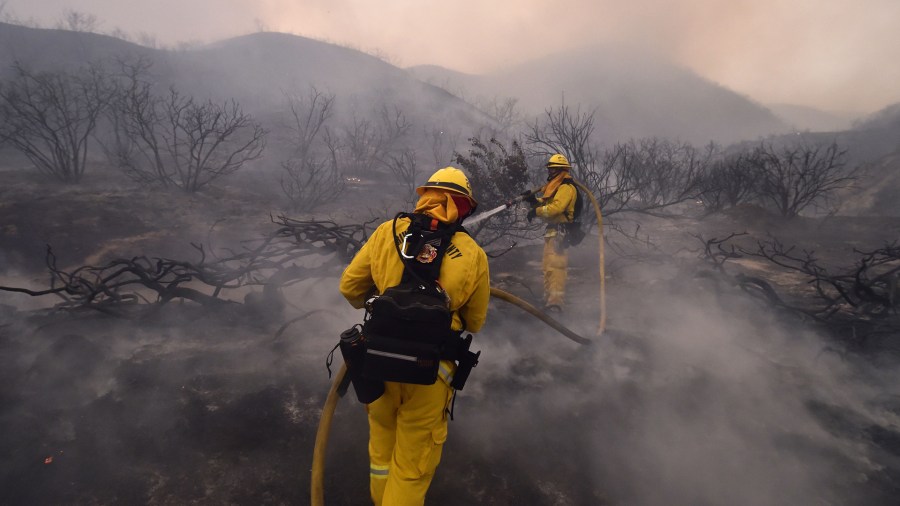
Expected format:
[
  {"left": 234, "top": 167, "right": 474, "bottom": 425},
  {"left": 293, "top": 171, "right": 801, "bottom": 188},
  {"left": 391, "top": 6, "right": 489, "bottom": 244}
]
[{"left": 408, "top": 47, "right": 790, "bottom": 144}]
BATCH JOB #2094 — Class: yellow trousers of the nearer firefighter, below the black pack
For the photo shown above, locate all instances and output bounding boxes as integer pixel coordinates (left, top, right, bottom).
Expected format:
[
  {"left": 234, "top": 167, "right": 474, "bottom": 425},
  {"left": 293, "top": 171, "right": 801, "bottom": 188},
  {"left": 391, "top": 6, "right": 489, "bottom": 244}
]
[{"left": 366, "top": 360, "right": 456, "bottom": 506}]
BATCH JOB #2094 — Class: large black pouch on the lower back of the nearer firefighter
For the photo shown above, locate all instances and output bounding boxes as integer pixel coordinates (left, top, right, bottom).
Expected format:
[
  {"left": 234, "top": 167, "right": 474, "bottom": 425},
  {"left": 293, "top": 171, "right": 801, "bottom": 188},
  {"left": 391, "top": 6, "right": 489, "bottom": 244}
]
[{"left": 363, "top": 282, "right": 452, "bottom": 385}]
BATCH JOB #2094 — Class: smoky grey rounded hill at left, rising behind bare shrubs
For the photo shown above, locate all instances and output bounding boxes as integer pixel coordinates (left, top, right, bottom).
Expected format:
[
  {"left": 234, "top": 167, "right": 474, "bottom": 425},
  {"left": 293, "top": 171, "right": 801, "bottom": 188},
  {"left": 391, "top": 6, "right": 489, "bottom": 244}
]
[{"left": 0, "top": 23, "right": 489, "bottom": 137}]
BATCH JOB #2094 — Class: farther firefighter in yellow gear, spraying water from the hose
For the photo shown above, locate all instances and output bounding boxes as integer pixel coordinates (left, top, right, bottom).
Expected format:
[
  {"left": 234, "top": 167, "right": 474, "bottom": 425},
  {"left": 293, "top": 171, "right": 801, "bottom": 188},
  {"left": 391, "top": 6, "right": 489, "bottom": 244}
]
[{"left": 525, "top": 153, "right": 578, "bottom": 312}]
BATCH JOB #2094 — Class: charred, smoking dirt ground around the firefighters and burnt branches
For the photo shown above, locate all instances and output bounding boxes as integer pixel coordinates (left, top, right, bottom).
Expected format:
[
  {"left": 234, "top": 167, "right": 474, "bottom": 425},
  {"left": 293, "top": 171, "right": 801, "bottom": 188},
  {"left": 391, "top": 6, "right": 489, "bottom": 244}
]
[{"left": 0, "top": 172, "right": 900, "bottom": 505}]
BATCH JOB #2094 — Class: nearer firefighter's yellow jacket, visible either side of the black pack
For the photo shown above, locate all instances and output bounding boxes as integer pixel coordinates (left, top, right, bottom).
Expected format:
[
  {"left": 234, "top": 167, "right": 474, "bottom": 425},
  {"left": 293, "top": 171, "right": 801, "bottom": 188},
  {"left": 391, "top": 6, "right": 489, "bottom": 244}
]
[{"left": 340, "top": 218, "right": 491, "bottom": 332}]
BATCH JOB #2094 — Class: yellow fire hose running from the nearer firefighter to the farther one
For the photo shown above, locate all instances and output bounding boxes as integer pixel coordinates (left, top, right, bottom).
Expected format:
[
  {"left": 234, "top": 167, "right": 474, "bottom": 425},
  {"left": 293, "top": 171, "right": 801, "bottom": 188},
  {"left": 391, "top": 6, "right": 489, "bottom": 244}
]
[{"left": 310, "top": 181, "right": 606, "bottom": 506}]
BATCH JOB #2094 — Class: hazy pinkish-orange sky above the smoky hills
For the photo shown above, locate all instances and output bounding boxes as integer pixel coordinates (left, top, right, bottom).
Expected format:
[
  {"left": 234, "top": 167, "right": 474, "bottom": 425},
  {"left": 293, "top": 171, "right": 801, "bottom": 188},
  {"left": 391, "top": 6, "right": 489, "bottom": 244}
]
[{"left": 7, "top": 0, "right": 900, "bottom": 112}]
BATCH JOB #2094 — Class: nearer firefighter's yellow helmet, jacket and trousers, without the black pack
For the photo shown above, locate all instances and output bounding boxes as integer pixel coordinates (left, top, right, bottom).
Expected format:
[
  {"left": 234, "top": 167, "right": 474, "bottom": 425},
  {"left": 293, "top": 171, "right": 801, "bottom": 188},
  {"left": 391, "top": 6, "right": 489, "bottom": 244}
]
[{"left": 340, "top": 167, "right": 490, "bottom": 506}]
